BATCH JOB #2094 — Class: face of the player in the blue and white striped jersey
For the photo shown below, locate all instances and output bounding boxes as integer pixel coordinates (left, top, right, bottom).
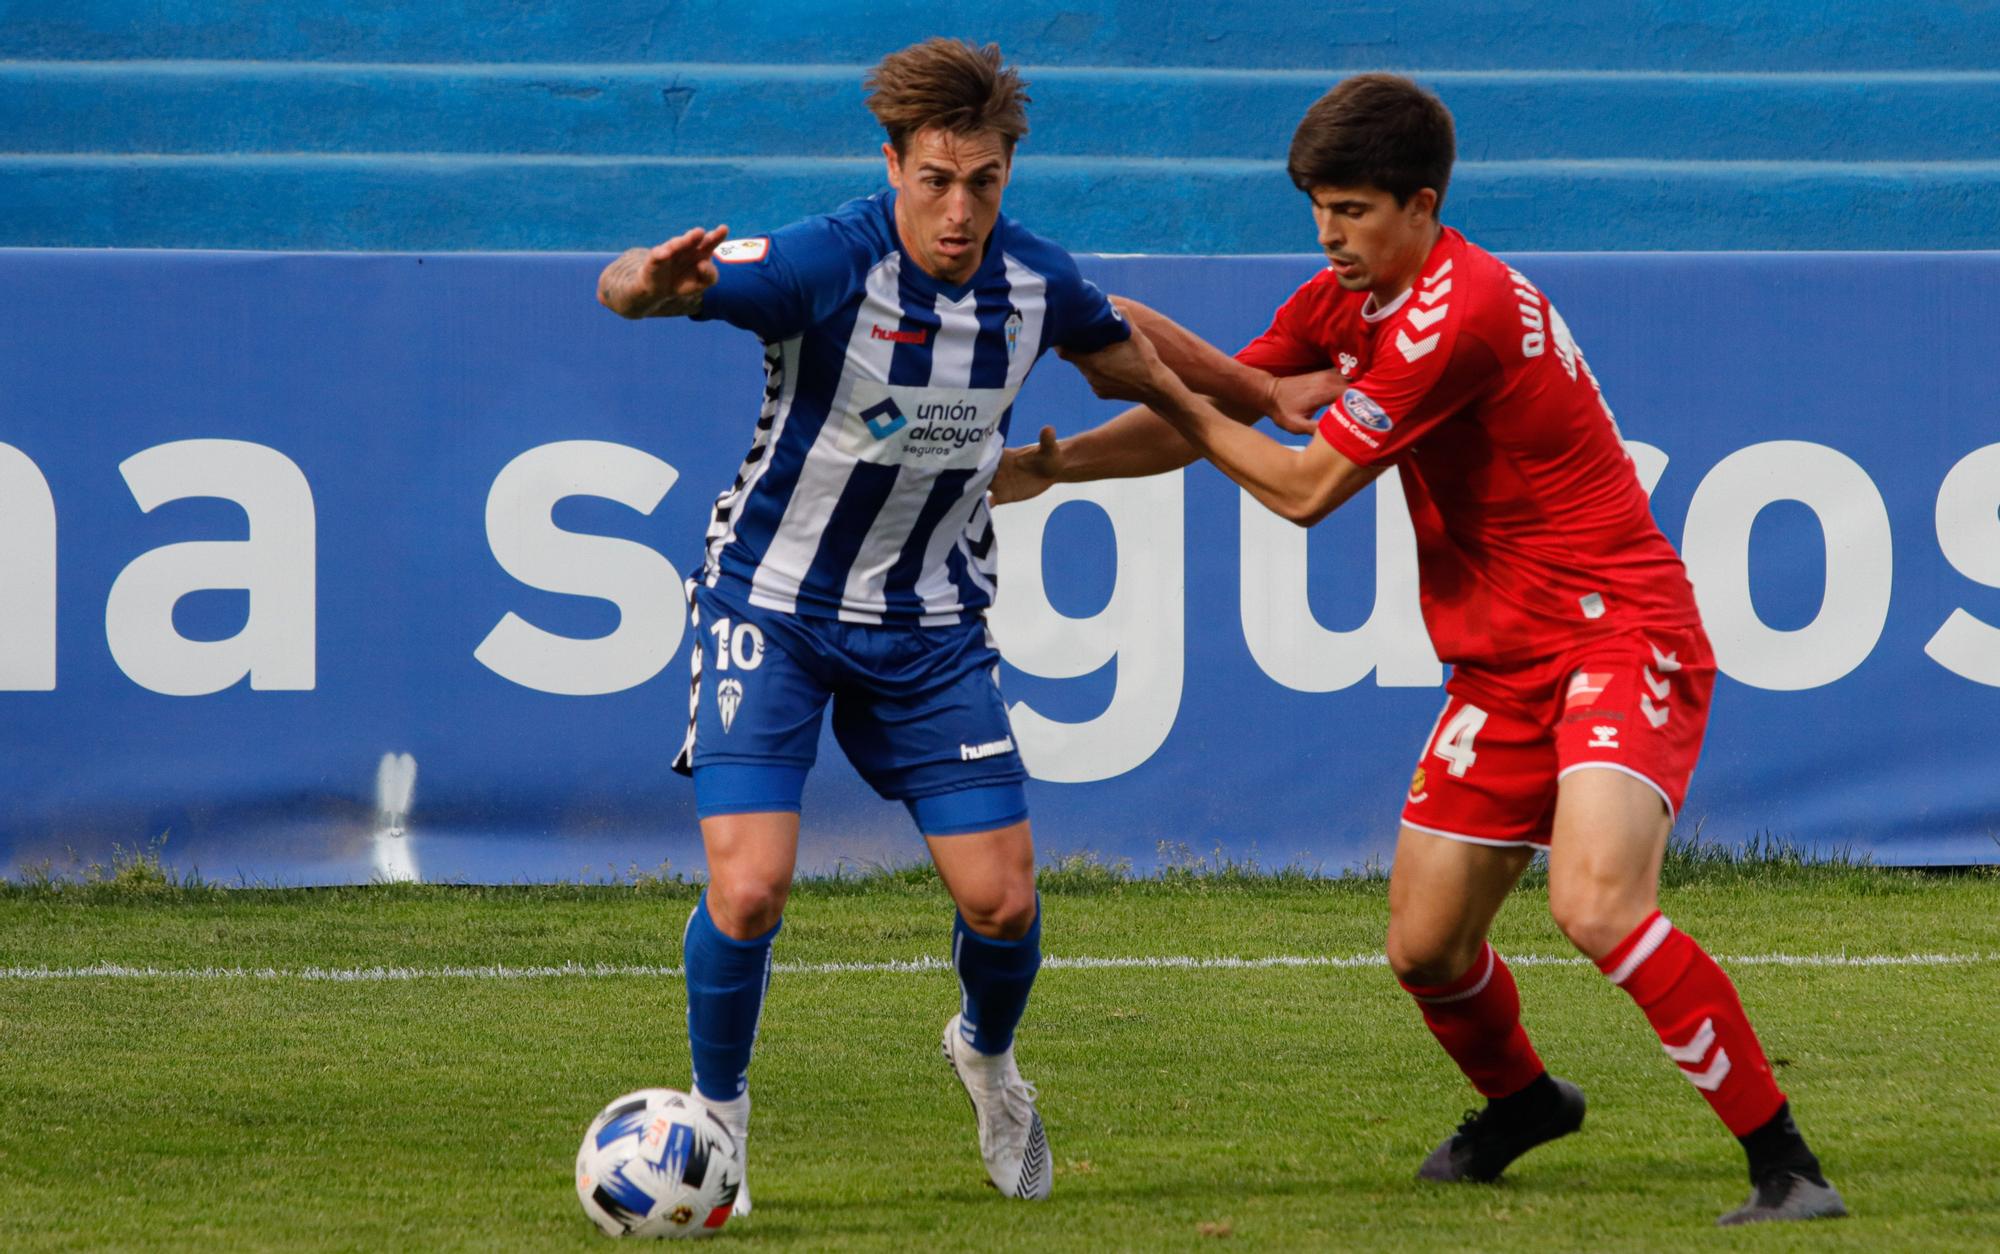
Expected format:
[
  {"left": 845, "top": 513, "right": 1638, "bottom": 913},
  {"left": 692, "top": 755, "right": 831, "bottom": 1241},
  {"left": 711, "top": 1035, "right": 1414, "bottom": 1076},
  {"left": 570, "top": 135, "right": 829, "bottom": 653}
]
[{"left": 882, "top": 126, "right": 1010, "bottom": 284}]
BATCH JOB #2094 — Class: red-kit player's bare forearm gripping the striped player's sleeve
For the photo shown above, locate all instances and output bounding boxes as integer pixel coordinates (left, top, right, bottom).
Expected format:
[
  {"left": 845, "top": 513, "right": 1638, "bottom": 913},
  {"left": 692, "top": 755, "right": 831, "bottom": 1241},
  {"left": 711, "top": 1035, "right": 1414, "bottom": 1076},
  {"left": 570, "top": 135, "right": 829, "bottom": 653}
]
[{"left": 1064, "top": 324, "right": 1382, "bottom": 526}]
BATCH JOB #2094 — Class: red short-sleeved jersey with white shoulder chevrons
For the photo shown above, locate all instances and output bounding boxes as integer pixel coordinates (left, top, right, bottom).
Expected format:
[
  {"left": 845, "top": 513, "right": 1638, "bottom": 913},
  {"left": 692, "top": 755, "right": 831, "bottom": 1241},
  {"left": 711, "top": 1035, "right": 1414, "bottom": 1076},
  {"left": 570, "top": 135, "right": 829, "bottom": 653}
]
[{"left": 1236, "top": 228, "right": 1700, "bottom": 664}]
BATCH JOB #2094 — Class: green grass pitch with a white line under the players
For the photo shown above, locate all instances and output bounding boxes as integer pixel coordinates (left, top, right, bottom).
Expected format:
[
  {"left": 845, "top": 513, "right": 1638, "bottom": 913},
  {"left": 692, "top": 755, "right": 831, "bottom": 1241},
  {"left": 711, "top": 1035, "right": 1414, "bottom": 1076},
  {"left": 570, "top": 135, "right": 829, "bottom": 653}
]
[{"left": 0, "top": 858, "right": 2000, "bottom": 1252}]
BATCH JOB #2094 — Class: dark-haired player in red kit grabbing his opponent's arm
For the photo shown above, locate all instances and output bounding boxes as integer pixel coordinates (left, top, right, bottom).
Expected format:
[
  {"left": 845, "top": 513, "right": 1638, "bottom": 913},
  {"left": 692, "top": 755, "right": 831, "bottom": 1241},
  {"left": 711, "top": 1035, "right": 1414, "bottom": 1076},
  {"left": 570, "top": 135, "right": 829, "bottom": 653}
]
[{"left": 994, "top": 74, "right": 1844, "bottom": 1224}]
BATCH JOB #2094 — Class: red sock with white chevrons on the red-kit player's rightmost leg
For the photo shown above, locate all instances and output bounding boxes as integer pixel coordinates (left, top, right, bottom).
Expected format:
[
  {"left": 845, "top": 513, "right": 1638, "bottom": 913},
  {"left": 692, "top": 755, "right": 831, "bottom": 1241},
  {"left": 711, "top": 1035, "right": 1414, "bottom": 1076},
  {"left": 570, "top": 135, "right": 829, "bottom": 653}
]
[{"left": 1598, "top": 910, "right": 1784, "bottom": 1136}]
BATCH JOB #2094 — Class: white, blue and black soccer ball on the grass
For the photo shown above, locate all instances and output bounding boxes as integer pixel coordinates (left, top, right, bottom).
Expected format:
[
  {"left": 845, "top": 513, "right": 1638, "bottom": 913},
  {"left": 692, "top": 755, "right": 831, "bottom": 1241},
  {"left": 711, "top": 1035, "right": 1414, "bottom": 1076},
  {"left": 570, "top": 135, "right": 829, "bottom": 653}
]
[{"left": 576, "top": 1088, "right": 744, "bottom": 1236}]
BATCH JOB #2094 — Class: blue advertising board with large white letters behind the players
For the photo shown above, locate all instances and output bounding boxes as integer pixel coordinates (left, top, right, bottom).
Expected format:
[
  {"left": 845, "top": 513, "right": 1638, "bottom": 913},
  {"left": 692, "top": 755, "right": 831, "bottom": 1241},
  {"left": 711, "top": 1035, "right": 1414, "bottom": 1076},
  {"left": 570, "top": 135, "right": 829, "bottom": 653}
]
[{"left": 0, "top": 250, "right": 2000, "bottom": 884}]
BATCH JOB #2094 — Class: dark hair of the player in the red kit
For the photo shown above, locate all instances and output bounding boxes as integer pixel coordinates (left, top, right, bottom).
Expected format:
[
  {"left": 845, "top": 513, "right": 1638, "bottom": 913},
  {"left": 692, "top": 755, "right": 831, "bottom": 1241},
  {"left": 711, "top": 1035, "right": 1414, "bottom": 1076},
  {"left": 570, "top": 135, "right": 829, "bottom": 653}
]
[{"left": 1286, "top": 74, "right": 1458, "bottom": 206}]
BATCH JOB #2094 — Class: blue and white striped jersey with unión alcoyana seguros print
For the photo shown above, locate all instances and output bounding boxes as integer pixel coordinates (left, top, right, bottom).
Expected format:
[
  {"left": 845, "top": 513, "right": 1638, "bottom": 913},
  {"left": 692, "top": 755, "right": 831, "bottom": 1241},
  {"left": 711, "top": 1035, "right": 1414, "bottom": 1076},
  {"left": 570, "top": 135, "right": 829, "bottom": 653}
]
[{"left": 696, "top": 192, "right": 1132, "bottom": 626}]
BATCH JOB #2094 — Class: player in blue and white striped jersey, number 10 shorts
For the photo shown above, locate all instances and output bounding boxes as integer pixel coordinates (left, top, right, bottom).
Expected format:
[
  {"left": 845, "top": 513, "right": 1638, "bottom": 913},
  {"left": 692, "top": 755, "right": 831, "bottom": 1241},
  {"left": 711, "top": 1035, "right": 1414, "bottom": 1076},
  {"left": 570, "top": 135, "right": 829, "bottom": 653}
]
[{"left": 598, "top": 40, "right": 1314, "bottom": 1210}]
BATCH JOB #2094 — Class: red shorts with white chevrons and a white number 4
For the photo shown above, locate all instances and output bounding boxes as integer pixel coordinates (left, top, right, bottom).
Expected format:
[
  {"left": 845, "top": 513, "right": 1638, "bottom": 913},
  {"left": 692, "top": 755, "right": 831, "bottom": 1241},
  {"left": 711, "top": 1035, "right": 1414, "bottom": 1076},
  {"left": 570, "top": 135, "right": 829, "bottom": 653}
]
[{"left": 1402, "top": 628, "right": 1716, "bottom": 848}]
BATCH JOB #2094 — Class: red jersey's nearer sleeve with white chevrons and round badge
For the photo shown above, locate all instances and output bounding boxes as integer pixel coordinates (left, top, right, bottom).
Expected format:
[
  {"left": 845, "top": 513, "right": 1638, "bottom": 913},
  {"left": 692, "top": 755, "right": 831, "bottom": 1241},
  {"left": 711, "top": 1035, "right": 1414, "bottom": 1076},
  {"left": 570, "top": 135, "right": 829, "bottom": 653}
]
[{"left": 1320, "top": 296, "right": 1500, "bottom": 466}]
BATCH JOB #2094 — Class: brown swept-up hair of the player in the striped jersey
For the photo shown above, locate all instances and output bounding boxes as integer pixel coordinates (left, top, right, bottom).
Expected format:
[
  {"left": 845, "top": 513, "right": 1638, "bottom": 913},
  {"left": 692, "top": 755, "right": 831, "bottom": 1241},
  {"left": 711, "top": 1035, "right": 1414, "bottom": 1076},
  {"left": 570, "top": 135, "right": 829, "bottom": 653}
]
[{"left": 862, "top": 38, "right": 1028, "bottom": 156}]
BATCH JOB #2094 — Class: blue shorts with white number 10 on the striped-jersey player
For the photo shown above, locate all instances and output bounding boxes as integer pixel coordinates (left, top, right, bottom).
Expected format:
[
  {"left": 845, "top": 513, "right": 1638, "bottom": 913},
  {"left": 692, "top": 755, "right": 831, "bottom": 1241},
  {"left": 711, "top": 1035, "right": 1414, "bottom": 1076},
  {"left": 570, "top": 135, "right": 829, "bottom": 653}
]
[{"left": 674, "top": 584, "right": 1028, "bottom": 802}]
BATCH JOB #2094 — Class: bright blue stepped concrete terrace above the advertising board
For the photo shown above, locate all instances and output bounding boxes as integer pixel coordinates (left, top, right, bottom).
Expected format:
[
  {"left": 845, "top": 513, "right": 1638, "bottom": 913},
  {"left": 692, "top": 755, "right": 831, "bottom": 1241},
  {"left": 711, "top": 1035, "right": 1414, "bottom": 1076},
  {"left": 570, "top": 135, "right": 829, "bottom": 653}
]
[{"left": 0, "top": 0, "right": 2000, "bottom": 252}]
